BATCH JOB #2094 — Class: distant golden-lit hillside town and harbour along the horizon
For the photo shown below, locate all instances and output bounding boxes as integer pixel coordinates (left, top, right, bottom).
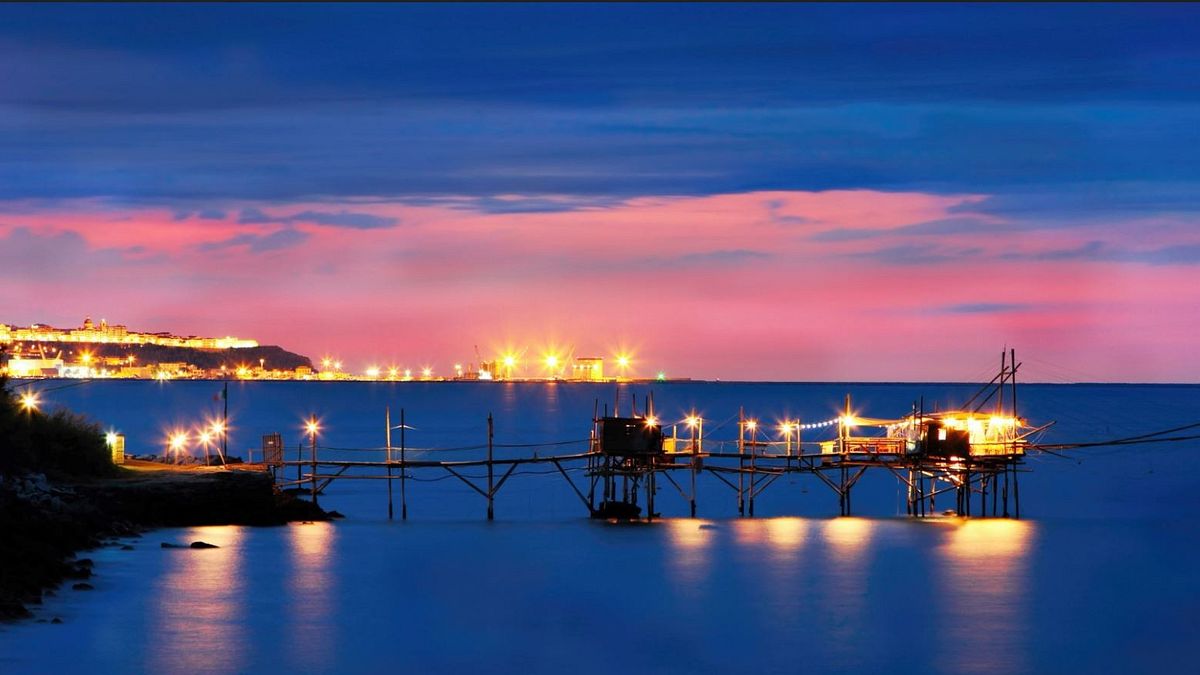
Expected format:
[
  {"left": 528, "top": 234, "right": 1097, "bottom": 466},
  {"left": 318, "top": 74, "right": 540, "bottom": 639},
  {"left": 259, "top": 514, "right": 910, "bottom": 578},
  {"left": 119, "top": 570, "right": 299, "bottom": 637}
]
[{"left": 0, "top": 317, "right": 666, "bottom": 382}]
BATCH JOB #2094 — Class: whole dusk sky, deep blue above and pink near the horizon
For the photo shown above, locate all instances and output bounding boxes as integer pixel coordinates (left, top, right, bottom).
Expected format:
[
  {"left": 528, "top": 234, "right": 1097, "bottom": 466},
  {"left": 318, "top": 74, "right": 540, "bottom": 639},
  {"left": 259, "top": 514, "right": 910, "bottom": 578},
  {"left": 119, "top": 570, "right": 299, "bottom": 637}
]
[{"left": 0, "top": 4, "right": 1200, "bottom": 382}]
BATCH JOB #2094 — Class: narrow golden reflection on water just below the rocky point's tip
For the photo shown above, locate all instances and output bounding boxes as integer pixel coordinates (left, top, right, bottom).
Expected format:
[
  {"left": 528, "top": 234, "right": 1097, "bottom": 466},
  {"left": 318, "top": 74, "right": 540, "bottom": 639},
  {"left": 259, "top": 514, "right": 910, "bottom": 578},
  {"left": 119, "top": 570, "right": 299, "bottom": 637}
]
[{"left": 288, "top": 522, "right": 337, "bottom": 670}]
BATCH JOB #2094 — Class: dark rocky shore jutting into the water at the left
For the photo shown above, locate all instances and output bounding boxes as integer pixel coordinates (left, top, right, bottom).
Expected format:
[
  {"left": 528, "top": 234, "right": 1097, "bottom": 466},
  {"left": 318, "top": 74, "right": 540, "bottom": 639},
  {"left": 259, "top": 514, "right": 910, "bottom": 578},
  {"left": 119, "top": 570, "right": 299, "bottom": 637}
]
[{"left": 0, "top": 462, "right": 329, "bottom": 620}]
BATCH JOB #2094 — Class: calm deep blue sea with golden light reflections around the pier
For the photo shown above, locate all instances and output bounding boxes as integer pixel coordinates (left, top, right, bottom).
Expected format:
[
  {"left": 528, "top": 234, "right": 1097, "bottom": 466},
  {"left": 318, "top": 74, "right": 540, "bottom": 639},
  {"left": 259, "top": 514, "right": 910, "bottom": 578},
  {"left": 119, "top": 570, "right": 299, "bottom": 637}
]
[{"left": 0, "top": 381, "right": 1200, "bottom": 675}]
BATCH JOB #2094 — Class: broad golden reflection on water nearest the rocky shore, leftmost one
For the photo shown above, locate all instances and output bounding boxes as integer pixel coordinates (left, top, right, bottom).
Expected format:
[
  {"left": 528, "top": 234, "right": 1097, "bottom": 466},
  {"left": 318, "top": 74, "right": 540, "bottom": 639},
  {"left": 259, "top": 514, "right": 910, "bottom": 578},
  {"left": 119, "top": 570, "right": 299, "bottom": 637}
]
[{"left": 146, "top": 526, "right": 246, "bottom": 673}]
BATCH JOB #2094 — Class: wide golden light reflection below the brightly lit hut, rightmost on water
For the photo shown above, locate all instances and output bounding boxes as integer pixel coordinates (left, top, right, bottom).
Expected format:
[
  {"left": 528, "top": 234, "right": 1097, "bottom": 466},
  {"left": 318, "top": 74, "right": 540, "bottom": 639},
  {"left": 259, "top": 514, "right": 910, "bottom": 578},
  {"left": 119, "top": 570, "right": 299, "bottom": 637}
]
[{"left": 937, "top": 519, "right": 1034, "bottom": 673}]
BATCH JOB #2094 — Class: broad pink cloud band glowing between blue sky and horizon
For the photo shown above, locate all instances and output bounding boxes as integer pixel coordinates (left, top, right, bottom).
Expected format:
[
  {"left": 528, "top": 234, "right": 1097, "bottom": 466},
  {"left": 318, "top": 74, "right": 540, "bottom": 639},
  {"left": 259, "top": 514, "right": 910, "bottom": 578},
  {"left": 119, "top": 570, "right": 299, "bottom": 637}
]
[{"left": 0, "top": 191, "right": 1200, "bottom": 381}]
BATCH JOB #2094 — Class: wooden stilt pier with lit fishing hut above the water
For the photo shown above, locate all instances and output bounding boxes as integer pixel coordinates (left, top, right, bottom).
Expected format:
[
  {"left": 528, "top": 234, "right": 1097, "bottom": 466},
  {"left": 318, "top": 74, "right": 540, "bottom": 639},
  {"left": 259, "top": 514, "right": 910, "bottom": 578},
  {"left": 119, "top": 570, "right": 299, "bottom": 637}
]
[{"left": 272, "top": 353, "right": 1049, "bottom": 520}]
